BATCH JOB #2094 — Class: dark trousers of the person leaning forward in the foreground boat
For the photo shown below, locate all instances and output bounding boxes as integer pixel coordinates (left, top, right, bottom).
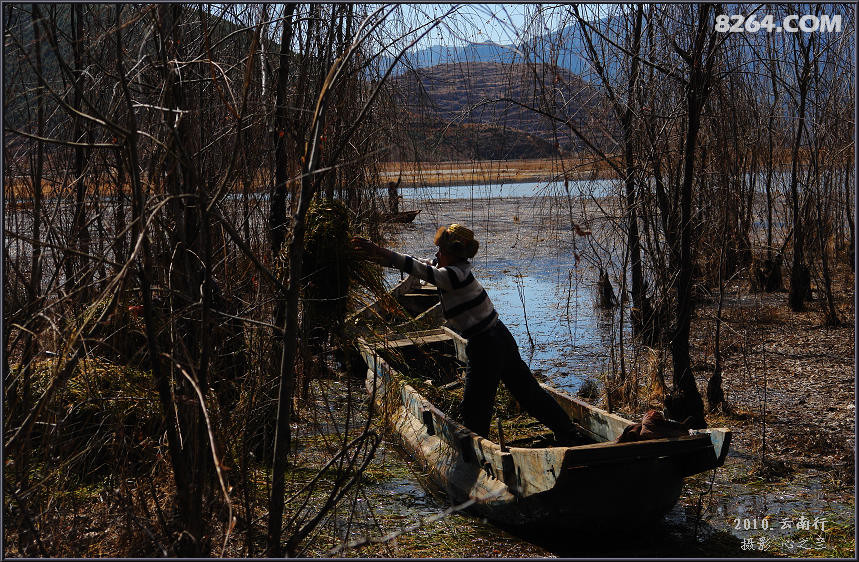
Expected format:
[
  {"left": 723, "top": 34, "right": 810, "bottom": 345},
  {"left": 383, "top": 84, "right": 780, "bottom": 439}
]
[{"left": 462, "top": 320, "right": 575, "bottom": 437}]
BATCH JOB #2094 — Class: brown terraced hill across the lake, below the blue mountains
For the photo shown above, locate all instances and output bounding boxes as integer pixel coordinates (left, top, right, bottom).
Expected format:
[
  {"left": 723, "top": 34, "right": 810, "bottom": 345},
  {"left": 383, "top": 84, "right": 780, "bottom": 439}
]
[{"left": 392, "top": 62, "right": 611, "bottom": 160}]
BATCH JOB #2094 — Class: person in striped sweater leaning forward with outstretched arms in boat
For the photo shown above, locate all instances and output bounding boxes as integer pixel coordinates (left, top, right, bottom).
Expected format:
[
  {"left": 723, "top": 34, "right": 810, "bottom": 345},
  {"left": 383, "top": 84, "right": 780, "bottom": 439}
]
[{"left": 352, "top": 224, "right": 577, "bottom": 444}]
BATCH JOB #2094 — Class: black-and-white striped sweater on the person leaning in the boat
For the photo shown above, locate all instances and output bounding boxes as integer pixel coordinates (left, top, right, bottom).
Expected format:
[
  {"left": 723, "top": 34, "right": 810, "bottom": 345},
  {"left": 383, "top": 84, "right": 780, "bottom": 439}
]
[{"left": 392, "top": 252, "right": 498, "bottom": 338}]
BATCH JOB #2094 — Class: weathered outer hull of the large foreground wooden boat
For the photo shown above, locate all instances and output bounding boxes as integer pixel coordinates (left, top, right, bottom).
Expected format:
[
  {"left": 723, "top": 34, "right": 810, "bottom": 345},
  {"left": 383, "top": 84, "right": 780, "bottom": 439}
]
[{"left": 362, "top": 331, "right": 730, "bottom": 534}]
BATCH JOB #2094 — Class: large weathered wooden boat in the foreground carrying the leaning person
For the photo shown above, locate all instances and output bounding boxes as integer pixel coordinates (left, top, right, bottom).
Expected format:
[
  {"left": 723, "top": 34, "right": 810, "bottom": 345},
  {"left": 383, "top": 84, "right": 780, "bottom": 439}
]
[{"left": 353, "top": 277, "right": 731, "bottom": 534}]
